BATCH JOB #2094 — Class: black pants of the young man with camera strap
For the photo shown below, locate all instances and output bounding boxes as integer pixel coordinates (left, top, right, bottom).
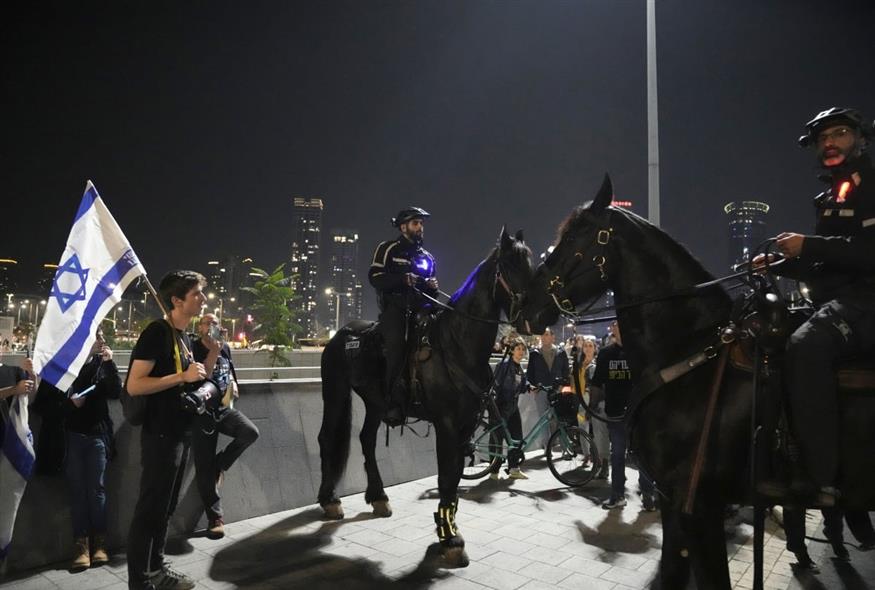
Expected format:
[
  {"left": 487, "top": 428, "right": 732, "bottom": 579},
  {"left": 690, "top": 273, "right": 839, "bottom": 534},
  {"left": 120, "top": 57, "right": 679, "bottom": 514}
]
[{"left": 128, "top": 430, "right": 191, "bottom": 589}]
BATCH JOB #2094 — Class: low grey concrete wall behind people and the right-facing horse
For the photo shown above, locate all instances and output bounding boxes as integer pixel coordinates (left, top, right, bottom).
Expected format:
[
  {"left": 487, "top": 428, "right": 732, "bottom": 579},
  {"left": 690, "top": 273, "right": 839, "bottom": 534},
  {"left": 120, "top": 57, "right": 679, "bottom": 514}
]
[{"left": 8, "top": 379, "right": 448, "bottom": 570}]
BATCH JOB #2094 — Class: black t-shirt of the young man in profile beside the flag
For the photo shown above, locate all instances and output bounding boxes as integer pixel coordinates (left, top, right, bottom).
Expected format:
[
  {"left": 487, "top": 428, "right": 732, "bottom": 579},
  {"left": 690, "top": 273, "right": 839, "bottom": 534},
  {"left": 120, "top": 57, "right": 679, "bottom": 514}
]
[{"left": 131, "top": 320, "right": 192, "bottom": 437}]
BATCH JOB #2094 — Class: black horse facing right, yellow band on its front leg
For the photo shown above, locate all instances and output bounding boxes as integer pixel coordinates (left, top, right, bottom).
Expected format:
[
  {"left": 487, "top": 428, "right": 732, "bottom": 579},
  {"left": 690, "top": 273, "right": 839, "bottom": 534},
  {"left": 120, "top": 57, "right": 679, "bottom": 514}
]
[{"left": 319, "top": 229, "right": 534, "bottom": 566}]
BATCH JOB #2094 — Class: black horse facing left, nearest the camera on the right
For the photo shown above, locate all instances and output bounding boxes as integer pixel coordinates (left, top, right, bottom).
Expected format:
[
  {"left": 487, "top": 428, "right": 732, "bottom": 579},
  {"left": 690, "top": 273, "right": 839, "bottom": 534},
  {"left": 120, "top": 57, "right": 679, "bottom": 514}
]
[{"left": 521, "top": 177, "right": 875, "bottom": 590}]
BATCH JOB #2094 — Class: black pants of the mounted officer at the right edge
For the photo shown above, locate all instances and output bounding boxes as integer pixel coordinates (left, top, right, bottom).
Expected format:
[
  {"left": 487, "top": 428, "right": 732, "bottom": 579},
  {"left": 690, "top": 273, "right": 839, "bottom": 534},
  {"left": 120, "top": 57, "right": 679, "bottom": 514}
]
[{"left": 786, "top": 299, "right": 875, "bottom": 486}]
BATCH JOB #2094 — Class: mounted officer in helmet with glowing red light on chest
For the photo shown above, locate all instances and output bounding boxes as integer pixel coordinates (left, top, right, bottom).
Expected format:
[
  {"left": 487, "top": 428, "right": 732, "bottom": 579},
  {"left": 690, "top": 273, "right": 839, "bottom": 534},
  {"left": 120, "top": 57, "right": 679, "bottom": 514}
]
[{"left": 776, "top": 108, "right": 875, "bottom": 503}]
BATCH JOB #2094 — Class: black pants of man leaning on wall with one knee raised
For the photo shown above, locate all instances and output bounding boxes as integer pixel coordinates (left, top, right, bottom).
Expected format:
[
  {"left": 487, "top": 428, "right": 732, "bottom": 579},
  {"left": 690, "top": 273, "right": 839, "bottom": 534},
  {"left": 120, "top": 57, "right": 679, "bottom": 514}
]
[{"left": 191, "top": 408, "right": 258, "bottom": 521}]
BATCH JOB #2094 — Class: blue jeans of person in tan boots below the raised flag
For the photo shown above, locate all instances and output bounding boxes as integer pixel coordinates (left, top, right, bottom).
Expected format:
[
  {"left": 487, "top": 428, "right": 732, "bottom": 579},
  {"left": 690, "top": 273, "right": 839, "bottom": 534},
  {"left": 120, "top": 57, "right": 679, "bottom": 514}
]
[{"left": 66, "top": 431, "right": 106, "bottom": 539}]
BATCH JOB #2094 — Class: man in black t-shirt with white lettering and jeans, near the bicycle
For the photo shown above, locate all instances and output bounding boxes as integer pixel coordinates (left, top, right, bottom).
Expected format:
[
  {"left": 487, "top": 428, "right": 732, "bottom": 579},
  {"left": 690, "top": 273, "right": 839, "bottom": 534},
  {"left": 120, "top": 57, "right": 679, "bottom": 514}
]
[{"left": 590, "top": 320, "right": 656, "bottom": 512}]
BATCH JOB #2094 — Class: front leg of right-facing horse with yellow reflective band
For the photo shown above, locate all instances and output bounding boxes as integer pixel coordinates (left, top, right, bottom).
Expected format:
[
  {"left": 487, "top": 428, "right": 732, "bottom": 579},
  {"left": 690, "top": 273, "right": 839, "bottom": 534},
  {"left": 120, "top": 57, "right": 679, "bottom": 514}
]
[{"left": 434, "top": 427, "right": 468, "bottom": 567}]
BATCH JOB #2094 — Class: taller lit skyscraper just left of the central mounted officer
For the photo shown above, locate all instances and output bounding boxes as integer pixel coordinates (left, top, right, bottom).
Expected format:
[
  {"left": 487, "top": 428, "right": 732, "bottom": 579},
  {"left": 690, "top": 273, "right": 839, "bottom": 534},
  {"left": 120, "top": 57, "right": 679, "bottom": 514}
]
[{"left": 287, "top": 197, "right": 322, "bottom": 338}]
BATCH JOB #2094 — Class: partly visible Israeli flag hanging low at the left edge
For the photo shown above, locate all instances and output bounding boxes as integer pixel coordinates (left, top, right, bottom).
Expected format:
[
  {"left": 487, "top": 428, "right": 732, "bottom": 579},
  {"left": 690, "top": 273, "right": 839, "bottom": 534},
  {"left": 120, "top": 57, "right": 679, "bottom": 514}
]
[{"left": 0, "top": 395, "right": 36, "bottom": 561}]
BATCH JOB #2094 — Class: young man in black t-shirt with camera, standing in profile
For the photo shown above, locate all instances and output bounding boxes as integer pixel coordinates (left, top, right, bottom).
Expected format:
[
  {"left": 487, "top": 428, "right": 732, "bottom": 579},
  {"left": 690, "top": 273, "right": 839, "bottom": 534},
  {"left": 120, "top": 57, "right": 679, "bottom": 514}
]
[{"left": 125, "top": 270, "right": 206, "bottom": 590}]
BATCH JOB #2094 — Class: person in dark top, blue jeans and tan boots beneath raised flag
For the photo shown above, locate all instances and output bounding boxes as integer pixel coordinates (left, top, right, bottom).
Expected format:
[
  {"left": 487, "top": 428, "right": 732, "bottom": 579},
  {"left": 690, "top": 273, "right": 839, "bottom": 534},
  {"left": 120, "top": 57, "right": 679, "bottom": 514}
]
[{"left": 58, "top": 328, "right": 122, "bottom": 571}]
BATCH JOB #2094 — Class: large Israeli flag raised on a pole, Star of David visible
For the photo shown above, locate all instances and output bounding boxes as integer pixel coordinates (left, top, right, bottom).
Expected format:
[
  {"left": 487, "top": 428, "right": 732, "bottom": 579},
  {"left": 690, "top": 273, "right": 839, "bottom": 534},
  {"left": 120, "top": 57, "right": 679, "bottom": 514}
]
[{"left": 33, "top": 180, "right": 146, "bottom": 391}]
